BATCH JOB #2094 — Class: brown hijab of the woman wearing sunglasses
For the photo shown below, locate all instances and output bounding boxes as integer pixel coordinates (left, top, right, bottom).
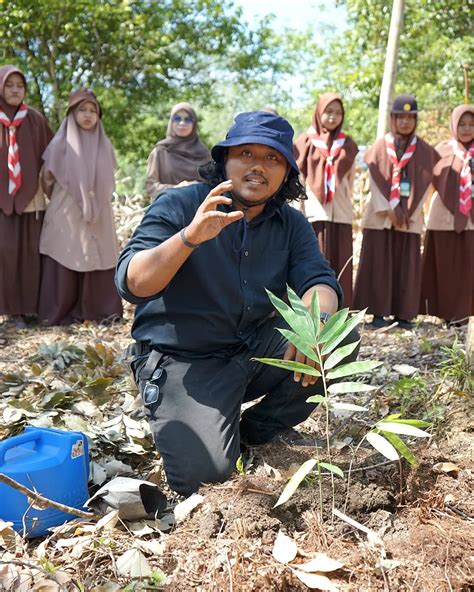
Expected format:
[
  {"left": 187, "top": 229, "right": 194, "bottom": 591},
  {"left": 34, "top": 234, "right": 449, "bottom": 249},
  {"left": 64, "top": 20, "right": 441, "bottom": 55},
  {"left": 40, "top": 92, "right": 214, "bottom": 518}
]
[{"left": 155, "top": 103, "right": 211, "bottom": 185}]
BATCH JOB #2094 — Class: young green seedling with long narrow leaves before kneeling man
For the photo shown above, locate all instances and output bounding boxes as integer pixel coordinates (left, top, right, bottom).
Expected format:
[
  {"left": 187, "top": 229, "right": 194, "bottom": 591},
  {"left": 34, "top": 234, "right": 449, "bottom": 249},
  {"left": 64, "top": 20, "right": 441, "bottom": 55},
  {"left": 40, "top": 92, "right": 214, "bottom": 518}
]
[{"left": 255, "top": 287, "right": 430, "bottom": 514}]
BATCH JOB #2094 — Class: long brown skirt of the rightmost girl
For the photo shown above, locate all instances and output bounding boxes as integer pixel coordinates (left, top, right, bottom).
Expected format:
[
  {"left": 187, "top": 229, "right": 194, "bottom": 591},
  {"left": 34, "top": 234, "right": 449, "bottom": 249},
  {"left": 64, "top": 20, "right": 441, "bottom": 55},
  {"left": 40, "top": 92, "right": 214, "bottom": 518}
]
[{"left": 420, "top": 230, "right": 474, "bottom": 321}]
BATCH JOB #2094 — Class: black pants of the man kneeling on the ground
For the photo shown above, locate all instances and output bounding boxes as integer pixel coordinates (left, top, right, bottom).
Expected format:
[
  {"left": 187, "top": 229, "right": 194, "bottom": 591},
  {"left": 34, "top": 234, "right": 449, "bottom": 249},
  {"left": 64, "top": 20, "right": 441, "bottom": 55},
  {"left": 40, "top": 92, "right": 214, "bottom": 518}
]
[{"left": 132, "top": 317, "right": 358, "bottom": 495}]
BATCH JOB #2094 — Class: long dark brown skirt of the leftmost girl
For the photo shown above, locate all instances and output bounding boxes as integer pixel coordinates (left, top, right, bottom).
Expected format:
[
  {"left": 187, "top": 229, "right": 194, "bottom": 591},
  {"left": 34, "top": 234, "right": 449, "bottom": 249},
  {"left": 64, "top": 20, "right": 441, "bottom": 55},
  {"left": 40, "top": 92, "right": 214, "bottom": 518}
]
[{"left": 0, "top": 211, "right": 44, "bottom": 315}]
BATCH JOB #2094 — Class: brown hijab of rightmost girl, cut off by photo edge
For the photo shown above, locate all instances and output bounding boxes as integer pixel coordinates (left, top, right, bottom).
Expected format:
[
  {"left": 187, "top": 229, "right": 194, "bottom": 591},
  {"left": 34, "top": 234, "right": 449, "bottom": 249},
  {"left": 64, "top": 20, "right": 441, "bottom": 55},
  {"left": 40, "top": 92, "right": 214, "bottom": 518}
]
[{"left": 433, "top": 105, "right": 474, "bottom": 233}]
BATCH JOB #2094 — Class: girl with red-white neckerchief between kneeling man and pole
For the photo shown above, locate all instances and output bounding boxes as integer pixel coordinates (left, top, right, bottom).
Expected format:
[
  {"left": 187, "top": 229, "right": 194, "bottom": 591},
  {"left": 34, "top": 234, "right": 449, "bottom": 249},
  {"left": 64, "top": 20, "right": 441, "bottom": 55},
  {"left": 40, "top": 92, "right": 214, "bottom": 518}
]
[{"left": 295, "top": 93, "right": 358, "bottom": 307}]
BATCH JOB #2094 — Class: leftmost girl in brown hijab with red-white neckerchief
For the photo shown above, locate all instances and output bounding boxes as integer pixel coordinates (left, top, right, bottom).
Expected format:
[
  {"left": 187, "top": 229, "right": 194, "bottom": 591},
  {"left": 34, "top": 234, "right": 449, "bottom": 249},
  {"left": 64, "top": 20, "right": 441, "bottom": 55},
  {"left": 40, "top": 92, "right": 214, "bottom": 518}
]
[{"left": 0, "top": 65, "right": 53, "bottom": 324}]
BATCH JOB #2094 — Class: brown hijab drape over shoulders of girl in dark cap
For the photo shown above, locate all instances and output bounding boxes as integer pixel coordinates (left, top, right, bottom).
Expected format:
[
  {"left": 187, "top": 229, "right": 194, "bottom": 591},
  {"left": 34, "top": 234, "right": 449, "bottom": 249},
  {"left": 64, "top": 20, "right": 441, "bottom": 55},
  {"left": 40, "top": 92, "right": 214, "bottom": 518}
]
[{"left": 364, "top": 108, "right": 437, "bottom": 223}]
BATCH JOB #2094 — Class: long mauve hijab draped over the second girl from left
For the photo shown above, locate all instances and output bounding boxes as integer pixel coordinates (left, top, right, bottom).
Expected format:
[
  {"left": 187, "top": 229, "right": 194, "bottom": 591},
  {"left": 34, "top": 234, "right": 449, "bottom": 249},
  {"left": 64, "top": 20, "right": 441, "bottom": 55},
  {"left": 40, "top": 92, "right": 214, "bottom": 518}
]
[{"left": 44, "top": 89, "right": 117, "bottom": 222}]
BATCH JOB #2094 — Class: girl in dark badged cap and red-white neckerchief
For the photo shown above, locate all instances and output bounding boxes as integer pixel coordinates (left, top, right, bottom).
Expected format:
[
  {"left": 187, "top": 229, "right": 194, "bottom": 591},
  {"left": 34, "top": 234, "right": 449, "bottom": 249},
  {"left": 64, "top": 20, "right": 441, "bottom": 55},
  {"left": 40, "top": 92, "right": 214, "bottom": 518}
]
[{"left": 354, "top": 95, "right": 436, "bottom": 329}]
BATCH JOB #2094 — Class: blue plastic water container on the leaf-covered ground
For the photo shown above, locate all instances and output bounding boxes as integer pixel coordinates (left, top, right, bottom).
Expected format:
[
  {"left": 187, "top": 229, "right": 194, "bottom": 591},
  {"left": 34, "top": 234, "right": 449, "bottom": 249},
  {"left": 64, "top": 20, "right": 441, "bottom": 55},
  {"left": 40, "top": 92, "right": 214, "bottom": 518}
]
[{"left": 0, "top": 426, "right": 89, "bottom": 538}]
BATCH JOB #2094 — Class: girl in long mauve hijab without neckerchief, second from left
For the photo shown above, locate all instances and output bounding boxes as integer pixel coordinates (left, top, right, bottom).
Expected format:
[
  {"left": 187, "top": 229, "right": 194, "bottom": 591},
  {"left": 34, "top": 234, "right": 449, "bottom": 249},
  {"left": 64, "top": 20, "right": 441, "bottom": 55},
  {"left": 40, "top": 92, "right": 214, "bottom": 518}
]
[{"left": 39, "top": 89, "right": 122, "bottom": 325}]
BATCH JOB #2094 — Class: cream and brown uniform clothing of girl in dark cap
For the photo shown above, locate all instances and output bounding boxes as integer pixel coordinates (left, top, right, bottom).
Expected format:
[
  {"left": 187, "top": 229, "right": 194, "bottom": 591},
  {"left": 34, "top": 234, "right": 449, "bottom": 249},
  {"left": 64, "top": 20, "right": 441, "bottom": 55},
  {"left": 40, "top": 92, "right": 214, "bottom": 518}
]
[{"left": 354, "top": 115, "right": 436, "bottom": 321}]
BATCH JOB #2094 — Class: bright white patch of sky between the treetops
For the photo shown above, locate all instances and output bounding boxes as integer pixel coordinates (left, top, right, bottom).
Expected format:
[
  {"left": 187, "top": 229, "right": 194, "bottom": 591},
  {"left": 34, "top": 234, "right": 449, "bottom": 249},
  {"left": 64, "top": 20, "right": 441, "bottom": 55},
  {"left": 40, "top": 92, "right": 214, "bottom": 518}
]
[{"left": 235, "top": 0, "right": 345, "bottom": 31}]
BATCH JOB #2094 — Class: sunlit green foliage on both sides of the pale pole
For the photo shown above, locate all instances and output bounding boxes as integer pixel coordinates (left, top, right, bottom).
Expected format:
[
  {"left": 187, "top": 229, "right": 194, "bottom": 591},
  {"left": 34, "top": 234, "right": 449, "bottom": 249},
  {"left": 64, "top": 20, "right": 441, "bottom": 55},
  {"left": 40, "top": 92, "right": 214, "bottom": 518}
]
[{"left": 302, "top": 0, "right": 474, "bottom": 144}]
